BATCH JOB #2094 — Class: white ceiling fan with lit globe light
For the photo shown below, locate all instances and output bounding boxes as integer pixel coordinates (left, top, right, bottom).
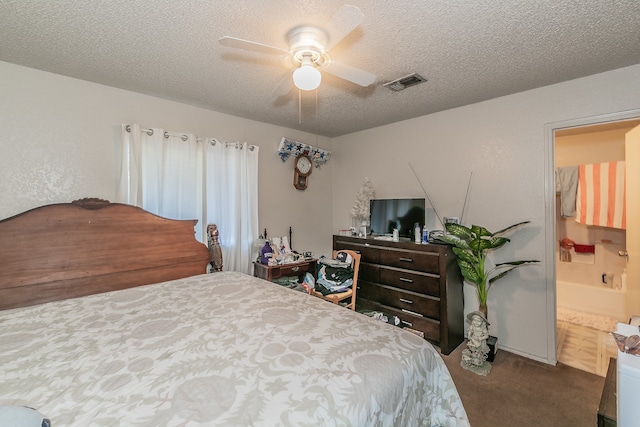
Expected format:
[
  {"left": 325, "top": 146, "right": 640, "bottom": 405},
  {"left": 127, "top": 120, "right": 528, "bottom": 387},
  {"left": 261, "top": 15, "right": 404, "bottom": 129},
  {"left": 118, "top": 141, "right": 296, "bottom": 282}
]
[{"left": 219, "top": 4, "right": 376, "bottom": 96}]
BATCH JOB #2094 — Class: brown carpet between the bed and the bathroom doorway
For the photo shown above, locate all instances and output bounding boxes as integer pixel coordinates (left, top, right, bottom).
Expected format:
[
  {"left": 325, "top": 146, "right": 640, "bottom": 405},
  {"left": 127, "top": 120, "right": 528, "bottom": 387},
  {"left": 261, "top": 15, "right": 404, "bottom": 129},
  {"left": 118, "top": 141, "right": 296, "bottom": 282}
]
[{"left": 442, "top": 343, "right": 604, "bottom": 427}]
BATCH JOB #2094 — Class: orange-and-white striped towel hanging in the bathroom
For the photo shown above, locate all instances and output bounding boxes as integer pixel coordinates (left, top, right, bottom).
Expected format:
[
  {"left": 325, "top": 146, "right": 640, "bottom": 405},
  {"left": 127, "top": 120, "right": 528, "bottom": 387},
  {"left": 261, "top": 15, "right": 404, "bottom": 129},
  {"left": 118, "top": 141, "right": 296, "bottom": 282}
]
[{"left": 576, "top": 161, "right": 627, "bottom": 230}]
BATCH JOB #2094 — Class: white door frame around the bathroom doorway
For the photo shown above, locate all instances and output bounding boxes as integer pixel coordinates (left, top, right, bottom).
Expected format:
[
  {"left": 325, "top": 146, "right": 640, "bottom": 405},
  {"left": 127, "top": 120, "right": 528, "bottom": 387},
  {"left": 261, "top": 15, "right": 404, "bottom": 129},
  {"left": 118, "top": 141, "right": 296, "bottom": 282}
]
[{"left": 544, "top": 109, "right": 640, "bottom": 365}]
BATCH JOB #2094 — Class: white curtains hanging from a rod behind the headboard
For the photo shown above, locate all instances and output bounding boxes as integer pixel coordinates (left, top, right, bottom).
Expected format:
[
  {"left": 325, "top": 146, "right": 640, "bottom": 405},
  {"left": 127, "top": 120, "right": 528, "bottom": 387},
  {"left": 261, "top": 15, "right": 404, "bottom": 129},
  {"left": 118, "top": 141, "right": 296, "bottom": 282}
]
[{"left": 118, "top": 124, "right": 259, "bottom": 274}]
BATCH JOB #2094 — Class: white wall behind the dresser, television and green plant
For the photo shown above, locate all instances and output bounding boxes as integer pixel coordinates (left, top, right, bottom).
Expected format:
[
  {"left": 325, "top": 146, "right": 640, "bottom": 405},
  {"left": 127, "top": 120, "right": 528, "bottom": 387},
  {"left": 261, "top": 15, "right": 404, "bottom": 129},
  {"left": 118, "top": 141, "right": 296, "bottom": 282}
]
[{"left": 332, "top": 65, "right": 640, "bottom": 363}]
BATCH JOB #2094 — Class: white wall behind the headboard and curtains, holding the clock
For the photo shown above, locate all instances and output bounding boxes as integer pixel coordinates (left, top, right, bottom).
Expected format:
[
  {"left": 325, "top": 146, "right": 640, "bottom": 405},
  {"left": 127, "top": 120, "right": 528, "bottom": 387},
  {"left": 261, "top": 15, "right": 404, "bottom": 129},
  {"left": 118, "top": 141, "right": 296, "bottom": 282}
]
[{"left": 0, "top": 62, "right": 332, "bottom": 255}]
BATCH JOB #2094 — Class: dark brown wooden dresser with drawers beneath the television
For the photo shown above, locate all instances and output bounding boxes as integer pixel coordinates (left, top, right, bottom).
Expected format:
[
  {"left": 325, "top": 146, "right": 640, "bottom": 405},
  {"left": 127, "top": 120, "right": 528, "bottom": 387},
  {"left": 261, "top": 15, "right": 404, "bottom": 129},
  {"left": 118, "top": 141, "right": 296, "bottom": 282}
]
[{"left": 333, "top": 235, "right": 464, "bottom": 354}]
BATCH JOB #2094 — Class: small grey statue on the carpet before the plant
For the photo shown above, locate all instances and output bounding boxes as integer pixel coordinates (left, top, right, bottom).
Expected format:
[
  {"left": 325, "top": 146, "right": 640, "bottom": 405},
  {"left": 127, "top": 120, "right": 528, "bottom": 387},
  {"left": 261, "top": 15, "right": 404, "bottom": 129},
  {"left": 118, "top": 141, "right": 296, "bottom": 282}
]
[{"left": 460, "top": 311, "right": 491, "bottom": 375}]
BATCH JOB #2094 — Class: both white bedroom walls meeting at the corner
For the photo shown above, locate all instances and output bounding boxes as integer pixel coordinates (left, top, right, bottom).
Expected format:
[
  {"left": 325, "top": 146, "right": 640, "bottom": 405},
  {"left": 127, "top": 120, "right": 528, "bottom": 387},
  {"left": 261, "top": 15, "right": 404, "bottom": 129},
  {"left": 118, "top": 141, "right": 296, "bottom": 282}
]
[{"left": 5, "top": 57, "right": 640, "bottom": 361}]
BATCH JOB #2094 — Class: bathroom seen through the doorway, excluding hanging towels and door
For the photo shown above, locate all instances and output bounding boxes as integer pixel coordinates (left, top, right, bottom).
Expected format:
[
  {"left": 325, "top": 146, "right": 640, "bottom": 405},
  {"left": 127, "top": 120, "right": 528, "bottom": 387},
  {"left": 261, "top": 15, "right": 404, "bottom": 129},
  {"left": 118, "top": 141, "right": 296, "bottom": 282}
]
[{"left": 553, "top": 113, "right": 640, "bottom": 376}]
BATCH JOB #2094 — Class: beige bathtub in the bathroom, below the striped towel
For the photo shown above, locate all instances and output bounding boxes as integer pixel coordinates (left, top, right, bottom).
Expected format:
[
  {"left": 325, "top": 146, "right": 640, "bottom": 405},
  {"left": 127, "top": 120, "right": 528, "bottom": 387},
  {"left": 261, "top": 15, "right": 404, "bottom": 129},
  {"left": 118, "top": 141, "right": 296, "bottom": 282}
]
[{"left": 556, "top": 281, "right": 626, "bottom": 321}]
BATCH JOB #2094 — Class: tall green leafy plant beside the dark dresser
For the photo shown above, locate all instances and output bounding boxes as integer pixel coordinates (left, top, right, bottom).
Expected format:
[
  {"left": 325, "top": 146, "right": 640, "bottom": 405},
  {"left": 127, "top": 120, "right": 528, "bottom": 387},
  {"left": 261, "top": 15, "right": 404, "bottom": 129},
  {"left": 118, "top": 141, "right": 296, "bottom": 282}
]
[{"left": 438, "top": 221, "right": 540, "bottom": 317}]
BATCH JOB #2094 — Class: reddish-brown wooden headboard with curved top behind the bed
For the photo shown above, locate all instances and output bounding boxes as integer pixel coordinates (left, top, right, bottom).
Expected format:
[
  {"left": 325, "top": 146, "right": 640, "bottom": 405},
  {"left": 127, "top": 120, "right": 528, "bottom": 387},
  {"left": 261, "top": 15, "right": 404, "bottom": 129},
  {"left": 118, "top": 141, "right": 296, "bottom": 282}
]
[{"left": 0, "top": 199, "right": 210, "bottom": 310}]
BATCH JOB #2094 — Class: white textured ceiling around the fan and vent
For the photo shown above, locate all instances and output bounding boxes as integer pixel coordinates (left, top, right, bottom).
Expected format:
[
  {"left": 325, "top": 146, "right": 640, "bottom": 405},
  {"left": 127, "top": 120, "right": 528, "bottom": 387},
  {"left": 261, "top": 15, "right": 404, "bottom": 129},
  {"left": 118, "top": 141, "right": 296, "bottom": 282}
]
[{"left": 0, "top": 0, "right": 640, "bottom": 137}]
